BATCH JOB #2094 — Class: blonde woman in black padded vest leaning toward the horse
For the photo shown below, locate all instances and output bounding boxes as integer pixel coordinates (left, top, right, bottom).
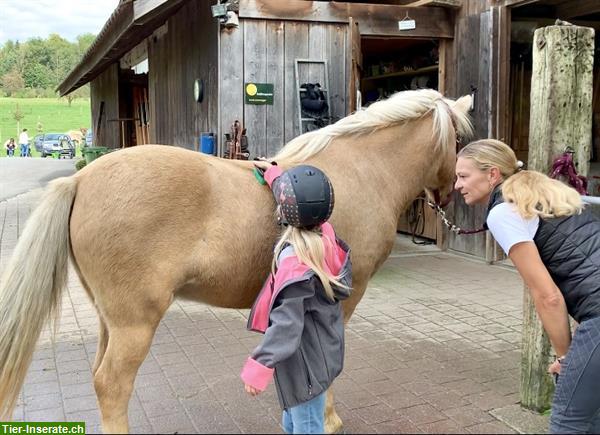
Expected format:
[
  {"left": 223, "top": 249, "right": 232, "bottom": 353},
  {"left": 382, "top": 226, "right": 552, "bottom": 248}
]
[{"left": 455, "top": 139, "right": 600, "bottom": 433}]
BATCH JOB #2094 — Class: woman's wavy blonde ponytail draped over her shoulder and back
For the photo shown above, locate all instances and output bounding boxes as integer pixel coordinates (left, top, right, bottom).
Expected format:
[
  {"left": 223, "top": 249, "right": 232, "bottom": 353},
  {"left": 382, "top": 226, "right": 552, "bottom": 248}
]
[{"left": 502, "top": 171, "right": 583, "bottom": 219}]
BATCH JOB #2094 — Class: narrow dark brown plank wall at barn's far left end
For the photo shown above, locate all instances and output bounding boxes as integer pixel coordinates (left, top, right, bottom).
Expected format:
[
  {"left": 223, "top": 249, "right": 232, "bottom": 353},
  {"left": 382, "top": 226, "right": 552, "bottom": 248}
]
[{"left": 90, "top": 62, "right": 119, "bottom": 148}]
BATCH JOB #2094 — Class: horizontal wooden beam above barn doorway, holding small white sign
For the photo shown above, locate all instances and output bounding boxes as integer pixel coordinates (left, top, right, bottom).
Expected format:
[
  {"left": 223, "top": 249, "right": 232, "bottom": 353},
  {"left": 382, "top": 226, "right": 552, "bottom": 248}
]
[{"left": 239, "top": 0, "right": 454, "bottom": 38}]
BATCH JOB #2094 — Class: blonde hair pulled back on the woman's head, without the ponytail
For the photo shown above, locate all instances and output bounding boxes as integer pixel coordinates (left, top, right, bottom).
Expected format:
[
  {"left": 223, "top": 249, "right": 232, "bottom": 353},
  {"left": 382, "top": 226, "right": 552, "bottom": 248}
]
[{"left": 457, "top": 139, "right": 521, "bottom": 179}]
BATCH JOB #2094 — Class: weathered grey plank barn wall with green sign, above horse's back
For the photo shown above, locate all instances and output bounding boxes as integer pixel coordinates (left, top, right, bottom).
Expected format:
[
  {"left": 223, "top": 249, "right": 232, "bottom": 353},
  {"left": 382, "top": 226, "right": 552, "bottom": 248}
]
[{"left": 219, "top": 19, "right": 348, "bottom": 158}]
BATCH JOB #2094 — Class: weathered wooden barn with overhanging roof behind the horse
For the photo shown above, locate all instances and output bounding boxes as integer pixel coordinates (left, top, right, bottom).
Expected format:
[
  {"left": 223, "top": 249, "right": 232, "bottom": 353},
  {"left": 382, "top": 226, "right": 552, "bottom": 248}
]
[{"left": 59, "top": 0, "right": 600, "bottom": 259}]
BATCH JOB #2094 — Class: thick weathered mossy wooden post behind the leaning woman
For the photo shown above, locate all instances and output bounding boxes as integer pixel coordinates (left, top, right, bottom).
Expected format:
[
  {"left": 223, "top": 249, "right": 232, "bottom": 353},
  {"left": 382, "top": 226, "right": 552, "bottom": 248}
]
[{"left": 521, "top": 22, "right": 594, "bottom": 411}]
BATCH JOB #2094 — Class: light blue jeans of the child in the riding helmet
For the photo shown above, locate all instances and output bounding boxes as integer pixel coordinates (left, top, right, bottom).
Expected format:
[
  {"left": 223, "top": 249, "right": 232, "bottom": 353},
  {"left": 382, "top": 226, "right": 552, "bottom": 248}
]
[{"left": 281, "top": 393, "right": 326, "bottom": 433}]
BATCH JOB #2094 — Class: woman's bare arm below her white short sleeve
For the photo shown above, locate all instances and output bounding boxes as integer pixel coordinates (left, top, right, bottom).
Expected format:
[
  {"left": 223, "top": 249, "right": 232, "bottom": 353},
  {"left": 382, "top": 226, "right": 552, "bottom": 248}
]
[{"left": 508, "top": 242, "right": 571, "bottom": 356}]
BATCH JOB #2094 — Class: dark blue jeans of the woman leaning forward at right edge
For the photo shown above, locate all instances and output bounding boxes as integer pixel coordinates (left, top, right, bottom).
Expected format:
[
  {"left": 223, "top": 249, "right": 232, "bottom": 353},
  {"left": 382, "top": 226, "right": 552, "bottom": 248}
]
[{"left": 550, "top": 317, "right": 600, "bottom": 434}]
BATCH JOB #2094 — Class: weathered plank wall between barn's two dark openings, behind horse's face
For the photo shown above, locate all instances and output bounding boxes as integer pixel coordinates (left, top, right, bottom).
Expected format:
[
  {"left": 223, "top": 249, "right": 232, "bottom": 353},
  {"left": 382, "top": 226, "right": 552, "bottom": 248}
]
[{"left": 446, "top": 0, "right": 496, "bottom": 257}]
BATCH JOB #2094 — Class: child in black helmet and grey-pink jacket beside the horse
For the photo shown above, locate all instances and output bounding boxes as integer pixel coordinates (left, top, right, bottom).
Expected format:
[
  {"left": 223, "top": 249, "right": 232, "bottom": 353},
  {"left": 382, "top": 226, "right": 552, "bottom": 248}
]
[{"left": 241, "top": 165, "right": 352, "bottom": 433}]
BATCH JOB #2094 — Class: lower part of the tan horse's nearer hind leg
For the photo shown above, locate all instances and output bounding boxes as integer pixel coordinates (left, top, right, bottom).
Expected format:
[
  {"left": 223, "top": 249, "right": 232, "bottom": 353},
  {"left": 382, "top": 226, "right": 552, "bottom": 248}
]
[{"left": 94, "top": 322, "right": 157, "bottom": 433}]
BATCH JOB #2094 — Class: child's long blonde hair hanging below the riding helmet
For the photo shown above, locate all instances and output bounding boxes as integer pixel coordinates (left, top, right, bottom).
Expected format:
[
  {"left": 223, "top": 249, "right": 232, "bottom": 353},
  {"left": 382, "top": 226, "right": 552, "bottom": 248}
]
[{"left": 271, "top": 225, "right": 348, "bottom": 301}]
